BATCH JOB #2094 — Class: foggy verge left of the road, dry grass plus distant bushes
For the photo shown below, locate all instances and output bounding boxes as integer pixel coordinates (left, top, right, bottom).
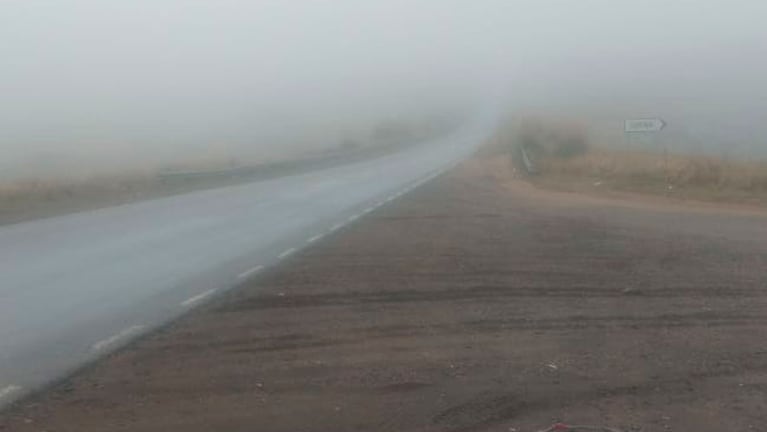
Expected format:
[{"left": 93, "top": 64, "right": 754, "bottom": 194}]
[{"left": 0, "top": 115, "right": 460, "bottom": 224}]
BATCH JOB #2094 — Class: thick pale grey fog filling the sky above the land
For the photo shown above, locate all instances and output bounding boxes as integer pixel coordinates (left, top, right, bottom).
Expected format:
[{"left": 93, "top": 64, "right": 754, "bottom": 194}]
[{"left": 0, "top": 0, "right": 767, "bottom": 177}]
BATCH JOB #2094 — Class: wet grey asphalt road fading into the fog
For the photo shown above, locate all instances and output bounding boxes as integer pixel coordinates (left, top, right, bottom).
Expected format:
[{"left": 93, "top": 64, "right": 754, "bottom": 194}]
[{"left": 0, "top": 128, "right": 482, "bottom": 406}]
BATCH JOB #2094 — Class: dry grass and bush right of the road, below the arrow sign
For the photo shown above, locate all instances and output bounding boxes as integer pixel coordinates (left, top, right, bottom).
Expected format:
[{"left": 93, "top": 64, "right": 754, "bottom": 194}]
[{"left": 495, "top": 119, "right": 767, "bottom": 205}]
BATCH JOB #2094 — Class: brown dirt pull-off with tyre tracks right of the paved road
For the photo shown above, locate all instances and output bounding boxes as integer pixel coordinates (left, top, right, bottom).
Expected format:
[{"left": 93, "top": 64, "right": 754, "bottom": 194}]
[{"left": 0, "top": 155, "right": 767, "bottom": 432}]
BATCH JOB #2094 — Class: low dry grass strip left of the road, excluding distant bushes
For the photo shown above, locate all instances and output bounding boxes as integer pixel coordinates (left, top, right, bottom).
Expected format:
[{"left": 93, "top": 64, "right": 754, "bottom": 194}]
[{"left": 0, "top": 136, "right": 428, "bottom": 225}]
